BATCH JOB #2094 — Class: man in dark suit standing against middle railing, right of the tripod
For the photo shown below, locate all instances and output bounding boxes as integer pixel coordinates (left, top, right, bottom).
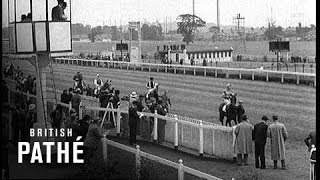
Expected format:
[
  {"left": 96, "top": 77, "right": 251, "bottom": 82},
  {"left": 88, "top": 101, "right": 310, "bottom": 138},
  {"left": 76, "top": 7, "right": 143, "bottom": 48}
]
[{"left": 129, "top": 101, "right": 140, "bottom": 145}]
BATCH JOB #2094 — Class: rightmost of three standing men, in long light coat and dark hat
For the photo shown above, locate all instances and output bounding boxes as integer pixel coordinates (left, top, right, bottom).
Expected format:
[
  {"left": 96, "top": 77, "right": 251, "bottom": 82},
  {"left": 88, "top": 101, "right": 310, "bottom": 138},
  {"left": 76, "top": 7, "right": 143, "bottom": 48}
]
[{"left": 267, "top": 115, "right": 288, "bottom": 170}]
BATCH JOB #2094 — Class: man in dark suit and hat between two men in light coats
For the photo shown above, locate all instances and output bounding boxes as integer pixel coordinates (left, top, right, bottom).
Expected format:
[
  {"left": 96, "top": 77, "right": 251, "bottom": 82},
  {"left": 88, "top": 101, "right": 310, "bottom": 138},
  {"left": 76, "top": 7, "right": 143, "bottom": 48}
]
[{"left": 252, "top": 116, "right": 268, "bottom": 169}]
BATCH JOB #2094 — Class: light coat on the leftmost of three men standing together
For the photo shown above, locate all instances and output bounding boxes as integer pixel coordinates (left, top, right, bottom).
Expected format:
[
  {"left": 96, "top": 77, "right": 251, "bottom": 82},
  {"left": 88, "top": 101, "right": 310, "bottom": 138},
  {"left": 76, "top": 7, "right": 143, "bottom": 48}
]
[{"left": 234, "top": 121, "right": 253, "bottom": 154}]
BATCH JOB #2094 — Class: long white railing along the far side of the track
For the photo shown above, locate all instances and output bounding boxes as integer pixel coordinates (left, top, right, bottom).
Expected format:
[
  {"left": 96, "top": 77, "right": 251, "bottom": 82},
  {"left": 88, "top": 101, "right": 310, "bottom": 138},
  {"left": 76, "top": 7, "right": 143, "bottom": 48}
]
[{"left": 54, "top": 58, "right": 316, "bottom": 86}]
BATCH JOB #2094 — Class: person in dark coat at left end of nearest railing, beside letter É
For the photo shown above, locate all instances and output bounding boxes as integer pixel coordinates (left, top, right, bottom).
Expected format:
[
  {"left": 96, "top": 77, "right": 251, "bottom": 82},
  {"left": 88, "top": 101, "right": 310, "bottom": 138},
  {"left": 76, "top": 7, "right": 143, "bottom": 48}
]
[{"left": 84, "top": 118, "right": 103, "bottom": 165}]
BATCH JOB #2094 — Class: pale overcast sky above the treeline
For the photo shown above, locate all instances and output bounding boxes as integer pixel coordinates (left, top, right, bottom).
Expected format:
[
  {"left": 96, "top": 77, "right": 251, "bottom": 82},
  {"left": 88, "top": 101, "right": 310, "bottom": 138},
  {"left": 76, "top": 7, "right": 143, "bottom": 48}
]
[{"left": 2, "top": 0, "right": 316, "bottom": 27}]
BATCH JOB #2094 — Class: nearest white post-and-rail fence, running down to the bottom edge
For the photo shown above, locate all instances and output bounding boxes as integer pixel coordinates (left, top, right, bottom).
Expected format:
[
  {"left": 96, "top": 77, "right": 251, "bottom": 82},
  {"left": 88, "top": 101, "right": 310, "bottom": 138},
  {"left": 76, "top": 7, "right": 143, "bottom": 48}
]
[{"left": 101, "top": 135, "right": 221, "bottom": 180}]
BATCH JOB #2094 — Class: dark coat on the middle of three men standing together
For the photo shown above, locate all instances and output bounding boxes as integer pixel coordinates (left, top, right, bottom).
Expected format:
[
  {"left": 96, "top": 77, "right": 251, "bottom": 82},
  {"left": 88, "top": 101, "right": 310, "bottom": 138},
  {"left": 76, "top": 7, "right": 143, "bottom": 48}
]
[{"left": 252, "top": 122, "right": 268, "bottom": 145}]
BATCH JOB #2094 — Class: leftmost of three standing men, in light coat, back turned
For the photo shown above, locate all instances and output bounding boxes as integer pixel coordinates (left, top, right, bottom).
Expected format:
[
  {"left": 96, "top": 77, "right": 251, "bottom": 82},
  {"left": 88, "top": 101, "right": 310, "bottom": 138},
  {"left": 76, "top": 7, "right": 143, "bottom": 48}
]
[{"left": 234, "top": 114, "right": 253, "bottom": 166}]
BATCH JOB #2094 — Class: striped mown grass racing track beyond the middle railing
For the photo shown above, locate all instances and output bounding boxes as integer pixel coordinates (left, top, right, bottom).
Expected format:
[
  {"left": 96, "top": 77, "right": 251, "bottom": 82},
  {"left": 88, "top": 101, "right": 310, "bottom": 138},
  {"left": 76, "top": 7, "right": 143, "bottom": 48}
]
[{"left": 11, "top": 62, "right": 316, "bottom": 179}]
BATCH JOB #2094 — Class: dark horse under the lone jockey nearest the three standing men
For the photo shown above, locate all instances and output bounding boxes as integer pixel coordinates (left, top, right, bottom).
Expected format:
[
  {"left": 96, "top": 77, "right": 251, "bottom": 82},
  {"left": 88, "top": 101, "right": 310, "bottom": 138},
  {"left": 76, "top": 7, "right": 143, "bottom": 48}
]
[{"left": 219, "top": 96, "right": 238, "bottom": 127}]
